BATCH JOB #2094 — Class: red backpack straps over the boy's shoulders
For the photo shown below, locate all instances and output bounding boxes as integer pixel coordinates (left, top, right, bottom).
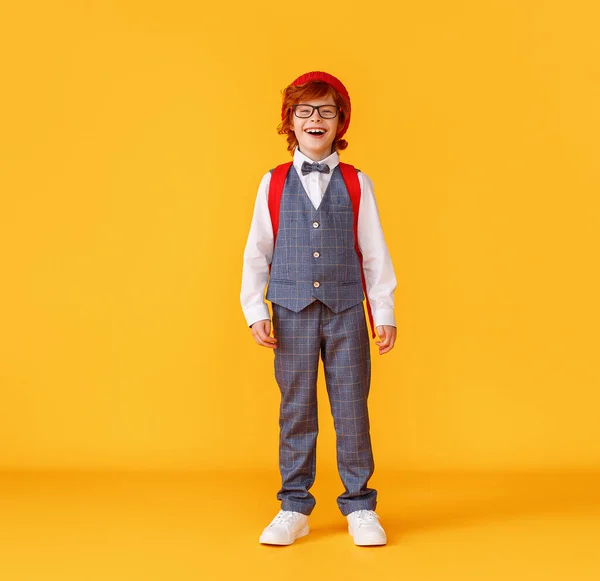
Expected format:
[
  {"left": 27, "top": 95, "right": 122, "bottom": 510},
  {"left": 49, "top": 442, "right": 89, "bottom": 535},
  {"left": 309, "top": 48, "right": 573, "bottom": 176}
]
[{"left": 269, "top": 161, "right": 376, "bottom": 339}]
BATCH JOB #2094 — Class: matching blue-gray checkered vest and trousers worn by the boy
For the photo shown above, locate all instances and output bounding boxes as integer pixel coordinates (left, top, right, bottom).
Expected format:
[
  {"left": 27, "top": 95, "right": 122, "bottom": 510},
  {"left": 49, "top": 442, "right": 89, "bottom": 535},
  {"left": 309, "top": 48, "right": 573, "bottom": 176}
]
[{"left": 267, "top": 166, "right": 377, "bottom": 515}]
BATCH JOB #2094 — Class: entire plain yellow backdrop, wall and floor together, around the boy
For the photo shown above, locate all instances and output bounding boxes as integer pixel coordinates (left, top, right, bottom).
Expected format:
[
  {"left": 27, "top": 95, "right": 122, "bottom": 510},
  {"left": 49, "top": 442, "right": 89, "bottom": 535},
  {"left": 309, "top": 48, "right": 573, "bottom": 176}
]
[{"left": 0, "top": 0, "right": 600, "bottom": 581}]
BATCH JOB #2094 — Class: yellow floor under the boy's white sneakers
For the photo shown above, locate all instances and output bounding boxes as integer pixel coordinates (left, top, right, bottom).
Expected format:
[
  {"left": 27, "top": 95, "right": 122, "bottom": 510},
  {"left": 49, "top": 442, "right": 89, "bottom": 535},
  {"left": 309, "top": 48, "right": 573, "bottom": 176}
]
[{"left": 0, "top": 471, "right": 600, "bottom": 581}]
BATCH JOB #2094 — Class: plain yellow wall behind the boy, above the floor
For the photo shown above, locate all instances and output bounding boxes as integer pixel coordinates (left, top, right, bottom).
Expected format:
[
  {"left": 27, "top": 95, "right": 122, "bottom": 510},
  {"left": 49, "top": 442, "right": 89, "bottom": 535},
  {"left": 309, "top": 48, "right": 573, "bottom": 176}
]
[{"left": 0, "top": 1, "right": 600, "bottom": 469}]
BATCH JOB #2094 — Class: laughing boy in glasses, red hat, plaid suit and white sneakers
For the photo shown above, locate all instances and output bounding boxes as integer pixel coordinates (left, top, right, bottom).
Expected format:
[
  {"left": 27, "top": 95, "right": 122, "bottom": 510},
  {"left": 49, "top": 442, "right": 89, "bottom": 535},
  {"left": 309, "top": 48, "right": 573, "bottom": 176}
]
[{"left": 240, "top": 71, "right": 396, "bottom": 546}]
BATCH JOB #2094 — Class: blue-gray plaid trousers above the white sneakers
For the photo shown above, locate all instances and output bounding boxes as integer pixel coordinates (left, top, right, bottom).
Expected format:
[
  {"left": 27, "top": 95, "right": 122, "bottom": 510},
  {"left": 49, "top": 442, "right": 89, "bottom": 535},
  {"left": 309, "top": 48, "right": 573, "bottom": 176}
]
[{"left": 273, "top": 300, "right": 377, "bottom": 516}]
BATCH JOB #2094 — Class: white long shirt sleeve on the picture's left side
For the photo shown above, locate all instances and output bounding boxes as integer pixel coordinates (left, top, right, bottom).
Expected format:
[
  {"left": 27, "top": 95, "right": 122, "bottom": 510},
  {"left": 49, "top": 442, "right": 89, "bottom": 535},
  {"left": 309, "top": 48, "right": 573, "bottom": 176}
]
[{"left": 240, "top": 172, "right": 273, "bottom": 327}]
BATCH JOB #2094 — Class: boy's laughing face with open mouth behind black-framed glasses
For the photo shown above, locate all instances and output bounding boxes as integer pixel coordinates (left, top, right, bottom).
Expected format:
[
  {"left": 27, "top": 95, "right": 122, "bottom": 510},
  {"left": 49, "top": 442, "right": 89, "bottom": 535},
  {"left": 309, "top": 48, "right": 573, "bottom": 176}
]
[{"left": 292, "top": 94, "right": 340, "bottom": 161}]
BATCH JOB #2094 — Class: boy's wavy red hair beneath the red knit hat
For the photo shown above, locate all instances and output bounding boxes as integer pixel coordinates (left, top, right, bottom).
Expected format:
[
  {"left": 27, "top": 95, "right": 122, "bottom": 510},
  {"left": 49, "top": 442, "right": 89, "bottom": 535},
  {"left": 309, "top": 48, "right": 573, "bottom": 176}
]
[{"left": 277, "top": 81, "right": 350, "bottom": 155}]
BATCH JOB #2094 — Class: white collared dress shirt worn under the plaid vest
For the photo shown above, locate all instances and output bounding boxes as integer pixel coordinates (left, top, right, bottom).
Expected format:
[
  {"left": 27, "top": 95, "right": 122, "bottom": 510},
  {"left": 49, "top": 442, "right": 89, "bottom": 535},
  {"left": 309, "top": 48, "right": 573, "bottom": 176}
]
[{"left": 240, "top": 147, "right": 396, "bottom": 327}]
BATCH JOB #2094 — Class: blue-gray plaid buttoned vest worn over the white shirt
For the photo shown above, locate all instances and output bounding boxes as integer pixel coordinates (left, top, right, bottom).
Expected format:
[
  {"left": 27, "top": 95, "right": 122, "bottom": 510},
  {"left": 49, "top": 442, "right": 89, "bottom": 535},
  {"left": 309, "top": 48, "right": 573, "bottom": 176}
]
[{"left": 267, "top": 166, "right": 364, "bottom": 313}]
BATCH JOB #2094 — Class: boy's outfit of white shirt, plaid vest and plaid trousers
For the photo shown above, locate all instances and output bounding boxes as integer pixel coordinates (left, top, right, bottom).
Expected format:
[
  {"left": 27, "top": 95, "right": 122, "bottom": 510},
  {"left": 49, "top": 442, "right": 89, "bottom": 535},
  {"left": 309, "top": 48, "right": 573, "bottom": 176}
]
[{"left": 240, "top": 148, "right": 396, "bottom": 515}]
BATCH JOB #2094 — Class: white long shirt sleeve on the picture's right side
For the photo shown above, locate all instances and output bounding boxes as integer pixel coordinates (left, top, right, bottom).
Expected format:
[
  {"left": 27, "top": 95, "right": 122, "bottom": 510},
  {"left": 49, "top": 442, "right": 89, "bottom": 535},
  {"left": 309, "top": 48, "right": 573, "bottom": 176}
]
[{"left": 358, "top": 172, "right": 397, "bottom": 327}]
